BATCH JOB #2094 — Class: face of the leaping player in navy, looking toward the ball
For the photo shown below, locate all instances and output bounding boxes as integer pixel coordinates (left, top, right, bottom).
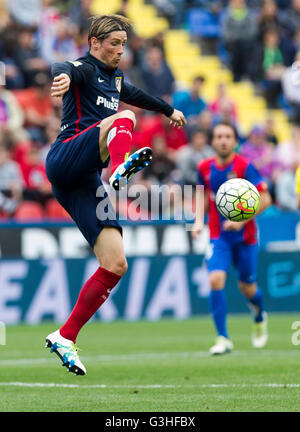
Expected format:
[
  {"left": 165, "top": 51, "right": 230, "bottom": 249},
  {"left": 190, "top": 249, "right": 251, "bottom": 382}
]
[{"left": 98, "top": 31, "right": 127, "bottom": 68}]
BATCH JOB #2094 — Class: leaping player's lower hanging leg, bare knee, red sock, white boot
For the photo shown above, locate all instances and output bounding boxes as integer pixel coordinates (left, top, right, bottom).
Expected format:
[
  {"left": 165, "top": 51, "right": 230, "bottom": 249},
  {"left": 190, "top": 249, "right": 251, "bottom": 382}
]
[{"left": 46, "top": 227, "right": 127, "bottom": 375}]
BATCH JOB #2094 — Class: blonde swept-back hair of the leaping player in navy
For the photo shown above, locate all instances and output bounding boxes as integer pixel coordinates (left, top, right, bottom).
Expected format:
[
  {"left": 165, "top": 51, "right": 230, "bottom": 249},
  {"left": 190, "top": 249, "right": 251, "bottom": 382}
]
[{"left": 88, "top": 14, "right": 131, "bottom": 45}]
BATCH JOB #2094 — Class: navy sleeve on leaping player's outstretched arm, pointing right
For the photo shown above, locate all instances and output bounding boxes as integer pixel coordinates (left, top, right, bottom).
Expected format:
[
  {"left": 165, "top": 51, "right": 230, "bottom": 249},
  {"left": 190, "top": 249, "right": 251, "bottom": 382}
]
[{"left": 120, "top": 82, "right": 174, "bottom": 117}]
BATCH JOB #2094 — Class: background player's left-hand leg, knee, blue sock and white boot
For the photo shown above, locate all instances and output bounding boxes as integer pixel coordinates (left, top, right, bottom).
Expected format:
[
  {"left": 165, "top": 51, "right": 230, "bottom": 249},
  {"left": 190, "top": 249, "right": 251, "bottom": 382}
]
[{"left": 209, "top": 270, "right": 233, "bottom": 355}]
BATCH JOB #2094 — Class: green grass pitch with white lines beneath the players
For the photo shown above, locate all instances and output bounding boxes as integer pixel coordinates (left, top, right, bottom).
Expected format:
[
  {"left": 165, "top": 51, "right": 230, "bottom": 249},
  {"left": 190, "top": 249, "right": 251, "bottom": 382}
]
[{"left": 0, "top": 314, "right": 300, "bottom": 412}]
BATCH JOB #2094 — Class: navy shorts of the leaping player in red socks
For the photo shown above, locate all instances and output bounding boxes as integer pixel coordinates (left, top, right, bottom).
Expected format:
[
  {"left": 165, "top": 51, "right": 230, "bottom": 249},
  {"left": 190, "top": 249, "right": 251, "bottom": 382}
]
[{"left": 46, "top": 122, "right": 122, "bottom": 248}]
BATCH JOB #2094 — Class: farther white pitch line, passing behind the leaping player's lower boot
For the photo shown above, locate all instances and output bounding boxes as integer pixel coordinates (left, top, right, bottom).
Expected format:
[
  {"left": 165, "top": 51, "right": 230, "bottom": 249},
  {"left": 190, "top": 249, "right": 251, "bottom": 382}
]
[{"left": 0, "top": 350, "right": 299, "bottom": 367}]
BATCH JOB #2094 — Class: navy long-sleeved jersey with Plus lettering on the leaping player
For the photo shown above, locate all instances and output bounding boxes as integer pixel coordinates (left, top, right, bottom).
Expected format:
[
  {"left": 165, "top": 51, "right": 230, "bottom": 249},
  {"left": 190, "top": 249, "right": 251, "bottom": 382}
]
[{"left": 52, "top": 53, "right": 174, "bottom": 139}]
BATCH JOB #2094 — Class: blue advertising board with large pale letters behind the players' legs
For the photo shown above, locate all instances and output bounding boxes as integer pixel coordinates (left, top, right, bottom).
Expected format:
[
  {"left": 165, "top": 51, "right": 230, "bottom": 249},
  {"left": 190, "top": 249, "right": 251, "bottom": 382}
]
[{"left": 0, "top": 250, "right": 300, "bottom": 324}]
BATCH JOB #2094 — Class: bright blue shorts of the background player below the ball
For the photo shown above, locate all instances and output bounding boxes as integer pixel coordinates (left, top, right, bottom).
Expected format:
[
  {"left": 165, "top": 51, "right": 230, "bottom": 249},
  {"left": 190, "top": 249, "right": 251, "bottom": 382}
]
[{"left": 206, "top": 239, "right": 258, "bottom": 283}]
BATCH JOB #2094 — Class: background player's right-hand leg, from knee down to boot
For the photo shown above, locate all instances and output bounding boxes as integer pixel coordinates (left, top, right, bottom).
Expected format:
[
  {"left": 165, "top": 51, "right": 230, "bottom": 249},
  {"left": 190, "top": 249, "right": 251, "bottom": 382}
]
[{"left": 239, "top": 281, "right": 268, "bottom": 348}]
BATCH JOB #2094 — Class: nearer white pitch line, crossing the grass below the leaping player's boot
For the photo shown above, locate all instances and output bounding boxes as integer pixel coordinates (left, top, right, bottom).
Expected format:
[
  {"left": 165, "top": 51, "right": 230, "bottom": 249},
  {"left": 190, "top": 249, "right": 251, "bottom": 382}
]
[{"left": 0, "top": 381, "right": 300, "bottom": 389}]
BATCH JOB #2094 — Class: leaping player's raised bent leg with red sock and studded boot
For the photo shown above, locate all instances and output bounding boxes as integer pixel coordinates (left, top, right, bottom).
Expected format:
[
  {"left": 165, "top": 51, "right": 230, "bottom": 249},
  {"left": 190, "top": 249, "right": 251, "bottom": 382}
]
[{"left": 99, "top": 110, "right": 152, "bottom": 190}]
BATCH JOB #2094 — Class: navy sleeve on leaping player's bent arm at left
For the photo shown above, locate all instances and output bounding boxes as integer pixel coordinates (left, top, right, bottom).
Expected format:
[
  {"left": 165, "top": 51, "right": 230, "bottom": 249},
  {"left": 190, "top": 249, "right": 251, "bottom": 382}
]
[{"left": 51, "top": 60, "right": 95, "bottom": 84}]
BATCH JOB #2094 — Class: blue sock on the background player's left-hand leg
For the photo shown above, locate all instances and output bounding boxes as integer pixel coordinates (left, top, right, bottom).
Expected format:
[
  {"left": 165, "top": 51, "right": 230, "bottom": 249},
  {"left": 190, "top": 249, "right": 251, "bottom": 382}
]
[{"left": 209, "top": 289, "right": 228, "bottom": 338}]
